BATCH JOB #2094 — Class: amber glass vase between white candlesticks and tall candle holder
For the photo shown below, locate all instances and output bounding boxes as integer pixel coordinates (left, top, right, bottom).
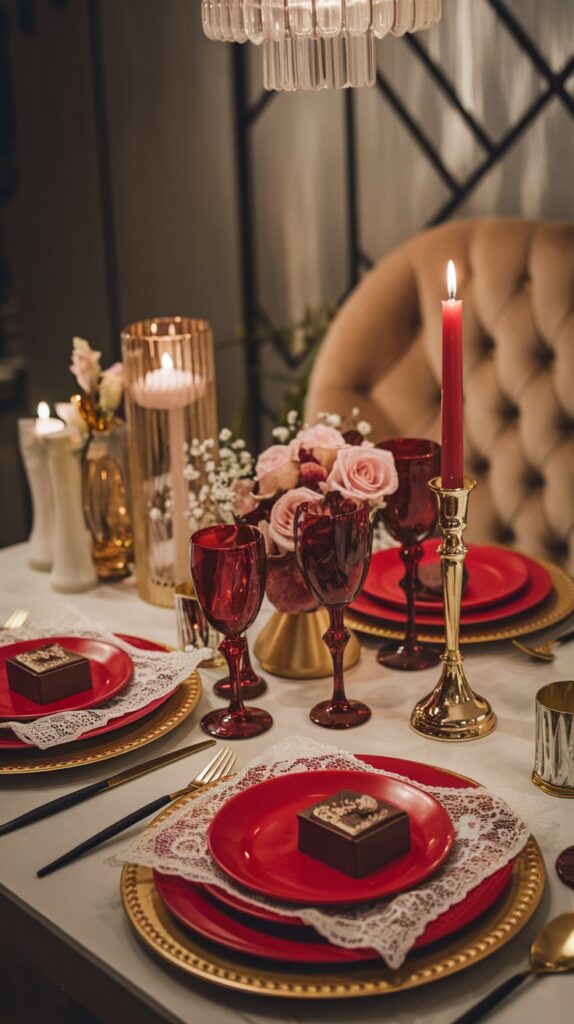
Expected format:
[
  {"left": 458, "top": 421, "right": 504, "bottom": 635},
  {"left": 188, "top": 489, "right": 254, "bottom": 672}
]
[{"left": 82, "top": 421, "right": 133, "bottom": 580}]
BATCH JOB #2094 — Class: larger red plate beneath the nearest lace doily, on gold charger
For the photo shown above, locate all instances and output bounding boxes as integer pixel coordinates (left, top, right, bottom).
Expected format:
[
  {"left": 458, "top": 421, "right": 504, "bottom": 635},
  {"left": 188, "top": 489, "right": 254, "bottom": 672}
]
[{"left": 153, "top": 755, "right": 513, "bottom": 964}]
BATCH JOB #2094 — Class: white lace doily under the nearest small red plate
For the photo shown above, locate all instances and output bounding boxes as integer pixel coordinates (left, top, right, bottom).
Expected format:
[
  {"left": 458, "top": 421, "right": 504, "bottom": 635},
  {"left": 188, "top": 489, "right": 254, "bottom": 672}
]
[{"left": 122, "top": 736, "right": 529, "bottom": 969}]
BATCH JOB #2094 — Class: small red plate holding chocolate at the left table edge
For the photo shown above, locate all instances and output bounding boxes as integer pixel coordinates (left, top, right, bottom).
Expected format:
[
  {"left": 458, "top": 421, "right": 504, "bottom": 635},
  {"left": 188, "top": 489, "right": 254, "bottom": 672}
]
[{"left": 0, "top": 637, "right": 133, "bottom": 721}]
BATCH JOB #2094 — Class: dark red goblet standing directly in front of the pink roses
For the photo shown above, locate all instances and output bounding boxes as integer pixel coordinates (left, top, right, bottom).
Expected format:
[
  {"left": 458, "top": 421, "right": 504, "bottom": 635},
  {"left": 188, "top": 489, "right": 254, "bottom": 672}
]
[{"left": 295, "top": 492, "right": 372, "bottom": 729}]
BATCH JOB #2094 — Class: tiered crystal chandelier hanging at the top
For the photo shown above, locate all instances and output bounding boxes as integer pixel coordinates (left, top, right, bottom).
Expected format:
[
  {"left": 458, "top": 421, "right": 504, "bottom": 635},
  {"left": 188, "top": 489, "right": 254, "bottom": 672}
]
[{"left": 202, "top": 0, "right": 442, "bottom": 91}]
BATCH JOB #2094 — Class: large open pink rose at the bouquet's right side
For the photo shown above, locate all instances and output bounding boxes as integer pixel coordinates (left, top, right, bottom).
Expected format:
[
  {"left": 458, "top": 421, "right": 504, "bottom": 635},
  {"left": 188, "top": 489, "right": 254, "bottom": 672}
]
[{"left": 323, "top": 446, "right": 399, "bottom": 506}]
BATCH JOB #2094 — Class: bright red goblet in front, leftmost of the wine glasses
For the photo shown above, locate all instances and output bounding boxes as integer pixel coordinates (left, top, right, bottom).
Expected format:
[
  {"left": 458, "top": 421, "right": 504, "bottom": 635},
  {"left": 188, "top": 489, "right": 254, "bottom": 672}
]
[{"left": 190, "top": 523, "right": 273, "bottom": 739}]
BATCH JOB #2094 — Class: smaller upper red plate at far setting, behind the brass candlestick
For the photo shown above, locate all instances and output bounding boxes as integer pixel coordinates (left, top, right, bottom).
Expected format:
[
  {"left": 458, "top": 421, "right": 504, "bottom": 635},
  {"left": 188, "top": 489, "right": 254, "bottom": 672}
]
[{"left": 363, "top": 538, "right": 529, "bottom": 615}]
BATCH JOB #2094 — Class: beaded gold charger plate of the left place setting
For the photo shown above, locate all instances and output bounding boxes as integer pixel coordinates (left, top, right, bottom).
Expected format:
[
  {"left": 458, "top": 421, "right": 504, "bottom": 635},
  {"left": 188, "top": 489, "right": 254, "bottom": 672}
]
[{"left": 0, "top": 672, "right": 202, "bottom": 775}]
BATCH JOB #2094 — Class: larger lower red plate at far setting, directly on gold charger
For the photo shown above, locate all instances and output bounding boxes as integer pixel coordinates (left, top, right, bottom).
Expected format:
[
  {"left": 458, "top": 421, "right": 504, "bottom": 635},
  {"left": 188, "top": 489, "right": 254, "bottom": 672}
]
[{"left": 349, "top": 555, "right": 553, "bottom": 630}]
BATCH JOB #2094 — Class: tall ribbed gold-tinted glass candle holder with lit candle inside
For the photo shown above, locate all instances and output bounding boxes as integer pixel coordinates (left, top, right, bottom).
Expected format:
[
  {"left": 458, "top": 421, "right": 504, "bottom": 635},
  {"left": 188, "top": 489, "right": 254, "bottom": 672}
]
[{"left": 122, "top": 316, "right": 217, "bottom": 607}]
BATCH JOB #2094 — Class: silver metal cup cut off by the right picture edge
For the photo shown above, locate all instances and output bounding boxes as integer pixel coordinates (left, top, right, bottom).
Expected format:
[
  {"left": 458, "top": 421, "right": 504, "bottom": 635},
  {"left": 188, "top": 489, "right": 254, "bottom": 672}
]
[{"left": 532, "top": 679, "right": 574, "bottom": 797}]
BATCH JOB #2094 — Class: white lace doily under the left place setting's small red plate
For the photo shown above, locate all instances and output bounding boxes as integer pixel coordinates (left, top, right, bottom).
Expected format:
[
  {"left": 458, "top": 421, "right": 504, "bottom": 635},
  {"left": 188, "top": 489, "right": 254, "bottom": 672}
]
[{"left": 0, "top": 614, "right": 211, "bottom": 751}]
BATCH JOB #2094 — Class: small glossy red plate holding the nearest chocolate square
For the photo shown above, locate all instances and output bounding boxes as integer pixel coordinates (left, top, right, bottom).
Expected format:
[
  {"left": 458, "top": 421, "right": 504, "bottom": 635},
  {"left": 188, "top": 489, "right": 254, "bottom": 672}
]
[{"left": 208, "top": 771, "right": 454, "bottom": 904}]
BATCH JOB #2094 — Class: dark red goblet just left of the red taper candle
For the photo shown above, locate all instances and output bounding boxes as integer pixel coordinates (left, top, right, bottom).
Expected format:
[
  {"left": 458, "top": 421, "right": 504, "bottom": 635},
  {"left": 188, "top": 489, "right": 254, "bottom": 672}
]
[{"left": 377, "top": 437, "right": 440, "bottom": 672}]
